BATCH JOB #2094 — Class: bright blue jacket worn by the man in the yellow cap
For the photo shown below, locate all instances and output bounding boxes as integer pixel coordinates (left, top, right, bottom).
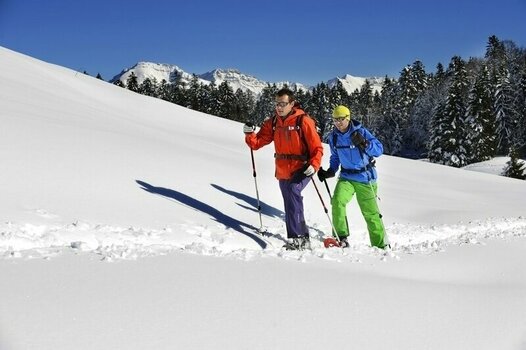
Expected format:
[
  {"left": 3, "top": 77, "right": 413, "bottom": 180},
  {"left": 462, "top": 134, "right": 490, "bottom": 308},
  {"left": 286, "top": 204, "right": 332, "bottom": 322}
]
[{"left": 329, "top": 120, "right": 384, "bottom": 183}]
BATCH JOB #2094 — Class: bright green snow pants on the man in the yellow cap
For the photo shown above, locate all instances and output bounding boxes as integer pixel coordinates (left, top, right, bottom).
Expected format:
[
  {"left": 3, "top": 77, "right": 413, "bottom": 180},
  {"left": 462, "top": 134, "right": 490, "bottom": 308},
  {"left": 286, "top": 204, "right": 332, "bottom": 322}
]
[{"left": 331, "top": 179, "right": 386, "bottom": 248}]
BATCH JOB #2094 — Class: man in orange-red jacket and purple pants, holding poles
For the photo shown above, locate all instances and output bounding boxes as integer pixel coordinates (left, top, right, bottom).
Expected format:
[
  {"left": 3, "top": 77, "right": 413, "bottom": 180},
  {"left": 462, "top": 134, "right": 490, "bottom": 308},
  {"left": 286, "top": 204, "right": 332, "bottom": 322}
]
[{"left": 243, "top": 88, "right": 323, "bottom": 250}]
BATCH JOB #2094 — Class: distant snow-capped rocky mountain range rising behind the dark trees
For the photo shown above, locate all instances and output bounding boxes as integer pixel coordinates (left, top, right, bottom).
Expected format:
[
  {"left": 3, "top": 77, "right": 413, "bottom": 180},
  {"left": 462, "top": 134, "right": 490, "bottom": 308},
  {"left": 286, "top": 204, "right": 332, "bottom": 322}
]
[{"left": 110, "top": 62, "right": 383, "bottom": 96}]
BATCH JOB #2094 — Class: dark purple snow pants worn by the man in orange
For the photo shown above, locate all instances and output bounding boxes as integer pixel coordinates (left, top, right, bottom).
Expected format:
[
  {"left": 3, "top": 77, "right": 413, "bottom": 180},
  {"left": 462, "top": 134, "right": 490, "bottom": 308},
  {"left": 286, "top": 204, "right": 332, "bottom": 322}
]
[{"left": 279, "top": 177, "right": 311, "bottom": 238}]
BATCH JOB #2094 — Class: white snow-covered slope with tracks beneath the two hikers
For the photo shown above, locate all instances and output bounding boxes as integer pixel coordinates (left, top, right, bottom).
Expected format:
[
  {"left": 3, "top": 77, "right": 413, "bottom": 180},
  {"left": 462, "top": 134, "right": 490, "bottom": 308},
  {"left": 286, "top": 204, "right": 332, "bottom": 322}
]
[{"left": 0, "top": 48, "right": 526, "bottom": 350}]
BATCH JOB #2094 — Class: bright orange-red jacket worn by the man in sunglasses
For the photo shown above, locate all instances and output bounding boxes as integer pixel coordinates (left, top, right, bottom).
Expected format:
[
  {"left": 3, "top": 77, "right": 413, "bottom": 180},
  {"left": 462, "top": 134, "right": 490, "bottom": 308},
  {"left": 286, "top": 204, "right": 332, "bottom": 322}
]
[{"left": 245, "top": 106, "right": 323, "bottom": 180}]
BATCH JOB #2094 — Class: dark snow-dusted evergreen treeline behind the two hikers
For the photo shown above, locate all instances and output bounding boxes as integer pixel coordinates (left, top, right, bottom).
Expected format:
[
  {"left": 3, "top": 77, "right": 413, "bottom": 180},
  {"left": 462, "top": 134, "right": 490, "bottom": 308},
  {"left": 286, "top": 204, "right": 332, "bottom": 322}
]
[{"left": 112, "top": 36, "right": 526, "bottom": 179}]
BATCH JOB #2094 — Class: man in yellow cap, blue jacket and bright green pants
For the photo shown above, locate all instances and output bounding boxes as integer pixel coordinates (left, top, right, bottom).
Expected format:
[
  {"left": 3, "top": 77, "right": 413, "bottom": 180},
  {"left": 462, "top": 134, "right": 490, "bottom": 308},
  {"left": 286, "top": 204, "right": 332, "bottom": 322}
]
[{"left": 318, "top": 106, "right": 388, "bottom": 249}]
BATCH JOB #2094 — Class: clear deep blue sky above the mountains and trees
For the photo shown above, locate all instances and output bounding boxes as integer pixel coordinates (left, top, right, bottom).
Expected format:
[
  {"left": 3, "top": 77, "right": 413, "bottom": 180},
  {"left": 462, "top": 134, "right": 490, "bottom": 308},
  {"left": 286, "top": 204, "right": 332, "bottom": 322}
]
[{"left": 0, "top": 0, "right": 526, "bottom": 84}]
